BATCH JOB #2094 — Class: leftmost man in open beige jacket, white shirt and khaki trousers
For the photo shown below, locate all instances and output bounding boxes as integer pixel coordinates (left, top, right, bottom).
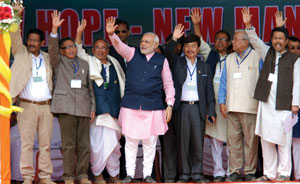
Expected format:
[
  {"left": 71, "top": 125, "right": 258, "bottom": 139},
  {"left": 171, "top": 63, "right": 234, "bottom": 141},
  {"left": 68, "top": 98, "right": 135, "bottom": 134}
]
[{"left": 10, "top": 6, "right": 54, "bottom": 184}]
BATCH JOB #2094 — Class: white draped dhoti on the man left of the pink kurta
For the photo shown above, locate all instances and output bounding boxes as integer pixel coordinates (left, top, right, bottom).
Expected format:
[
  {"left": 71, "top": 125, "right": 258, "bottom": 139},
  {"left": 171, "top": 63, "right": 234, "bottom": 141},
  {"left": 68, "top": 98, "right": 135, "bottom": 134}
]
[{"left": 90, "top": 114, "right": 121, "bottom": 177}]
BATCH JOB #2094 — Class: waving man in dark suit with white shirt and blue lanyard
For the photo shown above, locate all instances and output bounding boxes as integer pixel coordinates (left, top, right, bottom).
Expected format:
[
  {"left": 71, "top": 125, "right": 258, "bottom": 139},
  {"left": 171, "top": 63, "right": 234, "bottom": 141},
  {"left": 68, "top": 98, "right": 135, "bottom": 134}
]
[{"left": 164, "top": 24, "right": 216, "bottom": 183}]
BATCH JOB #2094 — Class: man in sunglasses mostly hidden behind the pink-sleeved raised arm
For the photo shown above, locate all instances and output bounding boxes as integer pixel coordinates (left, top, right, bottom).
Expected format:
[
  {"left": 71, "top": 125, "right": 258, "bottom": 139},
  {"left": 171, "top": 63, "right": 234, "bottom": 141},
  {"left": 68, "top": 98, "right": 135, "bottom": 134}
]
[{"left": 109, "top": 19, "right": 130, "bottom": 73}]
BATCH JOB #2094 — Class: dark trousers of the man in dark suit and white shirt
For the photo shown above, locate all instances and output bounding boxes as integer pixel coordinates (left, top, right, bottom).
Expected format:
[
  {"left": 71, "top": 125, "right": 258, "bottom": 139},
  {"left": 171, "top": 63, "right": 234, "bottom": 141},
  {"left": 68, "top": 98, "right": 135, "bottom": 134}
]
[{"left": 174, "top": 104, "right": 205, "bottom": 181}]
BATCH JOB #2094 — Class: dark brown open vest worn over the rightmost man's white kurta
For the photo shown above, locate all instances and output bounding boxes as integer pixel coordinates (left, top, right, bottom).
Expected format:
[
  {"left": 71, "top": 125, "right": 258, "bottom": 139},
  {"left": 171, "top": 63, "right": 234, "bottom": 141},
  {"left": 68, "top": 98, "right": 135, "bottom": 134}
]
[{"left": 254, "top": 47, "right": 298, "bottom": 110}]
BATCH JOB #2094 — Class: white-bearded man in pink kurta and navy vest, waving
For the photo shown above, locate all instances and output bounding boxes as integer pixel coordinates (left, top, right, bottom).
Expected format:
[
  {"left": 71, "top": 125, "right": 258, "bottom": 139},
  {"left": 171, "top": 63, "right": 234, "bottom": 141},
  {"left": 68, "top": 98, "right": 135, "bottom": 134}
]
[{"left": 106, "top": 17, "right": 175, "bottom": 183}]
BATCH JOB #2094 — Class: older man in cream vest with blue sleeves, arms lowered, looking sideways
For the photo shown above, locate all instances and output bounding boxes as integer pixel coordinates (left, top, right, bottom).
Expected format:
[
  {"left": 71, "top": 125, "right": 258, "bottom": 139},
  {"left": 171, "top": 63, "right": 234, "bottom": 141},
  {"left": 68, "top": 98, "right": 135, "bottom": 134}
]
[{"left": 218, "top": 30, "right": 263, "bottom": 181}]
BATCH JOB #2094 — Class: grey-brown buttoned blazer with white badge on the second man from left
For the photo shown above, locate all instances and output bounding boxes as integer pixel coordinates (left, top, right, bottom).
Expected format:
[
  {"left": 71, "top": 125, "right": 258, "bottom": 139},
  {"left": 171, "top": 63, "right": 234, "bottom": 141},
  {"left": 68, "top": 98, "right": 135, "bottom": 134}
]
[{"left": 48, "top": 36, "right": 96, "bottom": 117}]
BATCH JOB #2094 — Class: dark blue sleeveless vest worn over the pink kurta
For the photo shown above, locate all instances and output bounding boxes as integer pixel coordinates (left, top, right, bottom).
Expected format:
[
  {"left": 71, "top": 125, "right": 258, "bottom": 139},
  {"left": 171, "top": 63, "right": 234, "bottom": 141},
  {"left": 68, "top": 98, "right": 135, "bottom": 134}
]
[{"left": 121, "top": 48, "right": 165, "bottom": 110}]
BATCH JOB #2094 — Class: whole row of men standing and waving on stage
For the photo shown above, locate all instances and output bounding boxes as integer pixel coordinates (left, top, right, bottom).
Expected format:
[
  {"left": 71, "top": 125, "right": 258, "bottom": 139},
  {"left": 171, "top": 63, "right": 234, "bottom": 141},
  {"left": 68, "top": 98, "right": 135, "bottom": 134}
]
[{"left": 10, "top": 2, "right": 300, "bottom": 184}]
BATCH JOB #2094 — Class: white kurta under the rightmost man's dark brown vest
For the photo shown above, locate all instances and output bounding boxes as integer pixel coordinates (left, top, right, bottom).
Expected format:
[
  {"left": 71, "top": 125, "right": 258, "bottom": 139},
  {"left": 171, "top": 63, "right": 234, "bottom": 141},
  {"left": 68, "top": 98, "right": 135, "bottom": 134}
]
[{"left": 246, "top": 29, "right": 300, "bottom": 145}]
